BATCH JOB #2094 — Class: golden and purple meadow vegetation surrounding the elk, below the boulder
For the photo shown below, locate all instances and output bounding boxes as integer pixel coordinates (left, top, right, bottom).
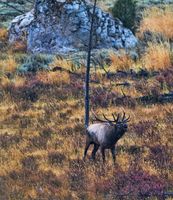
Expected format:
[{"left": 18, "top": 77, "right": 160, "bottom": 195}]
[{"left": 0, "top": 2, "right": 173, "bottom": 200}]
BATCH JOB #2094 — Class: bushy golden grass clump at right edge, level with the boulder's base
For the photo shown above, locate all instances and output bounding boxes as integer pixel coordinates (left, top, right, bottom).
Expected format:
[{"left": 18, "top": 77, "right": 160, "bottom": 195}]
[{"left": 142, "top": 43, "right": 172, "bottom": 70}]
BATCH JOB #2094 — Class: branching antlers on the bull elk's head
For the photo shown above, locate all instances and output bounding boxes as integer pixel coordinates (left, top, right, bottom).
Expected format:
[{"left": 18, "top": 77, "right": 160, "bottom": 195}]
[{"left": 92, "top": 111, "right": 130, "bottom": 123}]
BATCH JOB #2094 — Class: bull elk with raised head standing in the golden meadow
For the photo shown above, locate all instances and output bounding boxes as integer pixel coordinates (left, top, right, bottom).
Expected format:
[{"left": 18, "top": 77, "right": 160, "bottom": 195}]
[{"left": 83, "top": 113, "right": 130, "bottom": 163}]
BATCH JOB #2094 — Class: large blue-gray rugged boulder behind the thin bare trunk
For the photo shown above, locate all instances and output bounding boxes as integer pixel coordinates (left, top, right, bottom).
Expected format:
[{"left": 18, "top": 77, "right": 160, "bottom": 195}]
[{"left": 9, "top": 0, "right": 137, "bottom": 53}]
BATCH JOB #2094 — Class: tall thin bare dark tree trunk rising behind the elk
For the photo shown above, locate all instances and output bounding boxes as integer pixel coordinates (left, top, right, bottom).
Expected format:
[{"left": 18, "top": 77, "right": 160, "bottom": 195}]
[{"left": 85, "top": 0, "right": 97, "bottom": 128}]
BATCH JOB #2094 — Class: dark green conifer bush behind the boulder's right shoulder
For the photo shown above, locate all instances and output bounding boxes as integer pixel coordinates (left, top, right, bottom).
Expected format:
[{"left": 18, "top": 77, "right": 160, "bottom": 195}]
[{"left": 112, "top": 0, "right": 137, "bottom": 32}]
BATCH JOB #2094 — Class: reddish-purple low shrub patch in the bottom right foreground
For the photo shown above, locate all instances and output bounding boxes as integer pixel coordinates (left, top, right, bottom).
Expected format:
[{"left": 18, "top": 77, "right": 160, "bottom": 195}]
[{"left": 96, "top": 169, "right": 166, "bottom": 199}]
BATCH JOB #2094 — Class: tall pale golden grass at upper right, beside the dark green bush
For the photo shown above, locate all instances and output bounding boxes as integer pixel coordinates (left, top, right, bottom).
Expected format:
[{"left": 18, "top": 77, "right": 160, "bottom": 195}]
[{"left": 139, "top": 6, "right": 173, "bottom": 39}]
